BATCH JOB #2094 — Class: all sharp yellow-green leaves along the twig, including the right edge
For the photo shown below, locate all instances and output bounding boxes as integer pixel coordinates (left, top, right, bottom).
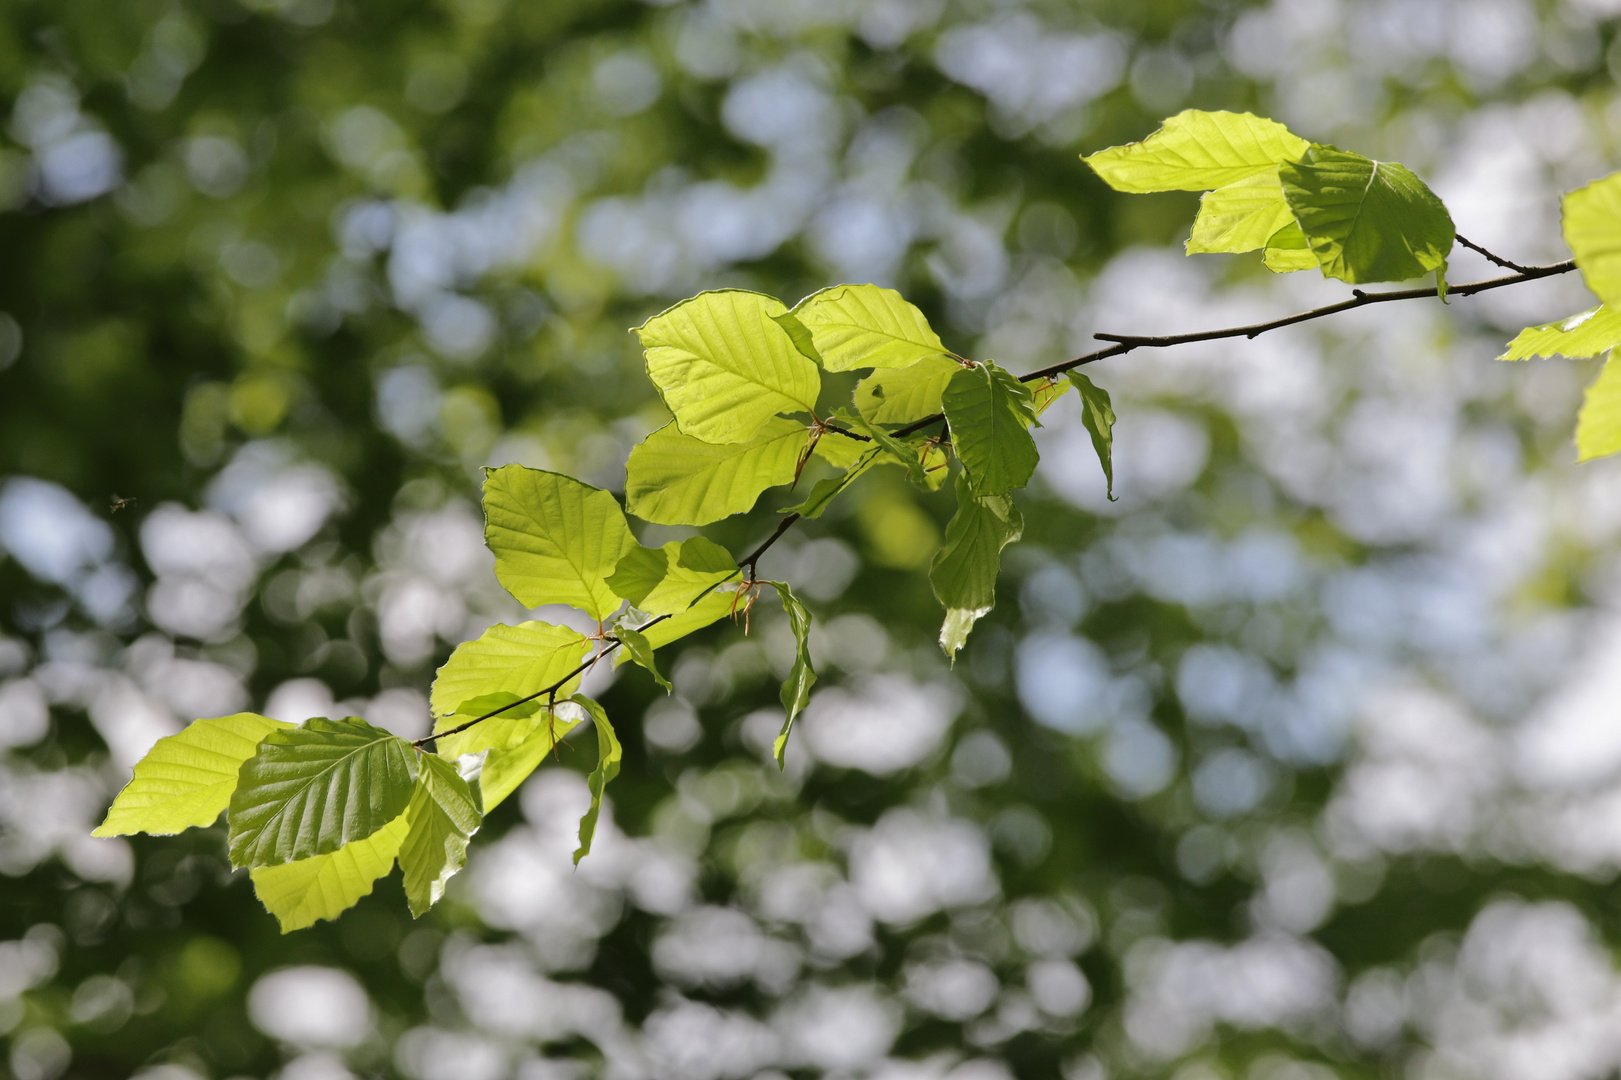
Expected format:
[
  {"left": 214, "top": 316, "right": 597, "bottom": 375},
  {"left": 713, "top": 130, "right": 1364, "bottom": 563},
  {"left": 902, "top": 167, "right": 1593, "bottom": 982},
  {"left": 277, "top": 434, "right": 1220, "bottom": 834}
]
[{"left": 97, "top": 110, "right": 1621, "bottom": 931}]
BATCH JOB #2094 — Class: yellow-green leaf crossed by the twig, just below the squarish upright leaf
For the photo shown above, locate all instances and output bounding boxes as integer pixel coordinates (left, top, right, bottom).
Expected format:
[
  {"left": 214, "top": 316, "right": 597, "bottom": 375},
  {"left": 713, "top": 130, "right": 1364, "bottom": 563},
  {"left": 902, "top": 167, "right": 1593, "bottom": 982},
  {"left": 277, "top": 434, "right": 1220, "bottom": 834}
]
[{"left": 428, "top": 623, "right": 590, "bottom": 757}]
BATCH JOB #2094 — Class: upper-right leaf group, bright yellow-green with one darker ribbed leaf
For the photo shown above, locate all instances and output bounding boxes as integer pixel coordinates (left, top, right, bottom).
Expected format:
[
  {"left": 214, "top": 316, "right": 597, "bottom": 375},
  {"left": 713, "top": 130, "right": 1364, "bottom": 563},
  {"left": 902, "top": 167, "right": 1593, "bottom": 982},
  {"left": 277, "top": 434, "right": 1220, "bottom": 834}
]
[{"left": 1084, "top": 109, "right": 1454, "bottom": 284}]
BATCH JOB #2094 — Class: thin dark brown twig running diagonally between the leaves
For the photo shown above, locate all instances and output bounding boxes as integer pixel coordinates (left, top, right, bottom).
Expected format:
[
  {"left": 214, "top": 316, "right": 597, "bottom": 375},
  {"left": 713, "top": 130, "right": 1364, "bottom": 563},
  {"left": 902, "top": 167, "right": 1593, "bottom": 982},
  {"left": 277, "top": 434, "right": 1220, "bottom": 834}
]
[{"left": 412, "top": 261, "right": 1576, "bottom": 748}]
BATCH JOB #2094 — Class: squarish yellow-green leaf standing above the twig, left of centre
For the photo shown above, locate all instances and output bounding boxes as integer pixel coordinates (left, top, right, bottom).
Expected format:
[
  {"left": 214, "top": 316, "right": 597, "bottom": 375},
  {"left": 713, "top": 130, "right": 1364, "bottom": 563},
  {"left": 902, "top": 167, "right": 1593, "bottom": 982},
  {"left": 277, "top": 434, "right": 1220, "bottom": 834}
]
[{"left": 485, "top": 465, "right": 635, "bottom": 621}]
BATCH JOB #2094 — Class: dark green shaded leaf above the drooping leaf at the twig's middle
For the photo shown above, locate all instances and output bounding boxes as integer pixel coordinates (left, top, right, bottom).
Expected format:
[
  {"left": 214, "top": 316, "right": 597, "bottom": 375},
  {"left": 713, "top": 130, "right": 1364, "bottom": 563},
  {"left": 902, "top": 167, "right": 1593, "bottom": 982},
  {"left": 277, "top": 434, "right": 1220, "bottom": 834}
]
[{"left": 940, "top": 363, "right": 1037, "bottom": 495}]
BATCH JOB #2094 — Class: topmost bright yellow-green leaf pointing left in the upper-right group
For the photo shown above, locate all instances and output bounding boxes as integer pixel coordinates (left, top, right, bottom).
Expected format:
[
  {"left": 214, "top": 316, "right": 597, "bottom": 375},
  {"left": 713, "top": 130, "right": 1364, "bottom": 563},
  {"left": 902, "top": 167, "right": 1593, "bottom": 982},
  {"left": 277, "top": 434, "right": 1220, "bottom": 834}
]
[{"left": 1083, "top": 109, "right": 1310, "bottom": 191}]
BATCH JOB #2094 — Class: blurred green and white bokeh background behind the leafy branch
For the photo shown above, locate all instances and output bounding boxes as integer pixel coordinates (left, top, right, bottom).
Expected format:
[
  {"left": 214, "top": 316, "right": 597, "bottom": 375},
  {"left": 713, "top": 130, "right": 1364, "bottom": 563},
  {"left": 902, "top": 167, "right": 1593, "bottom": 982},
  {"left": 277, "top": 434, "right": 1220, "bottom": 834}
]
[{"left": 0, "top": 0, "right": 1621, "bottom": 1080}]
